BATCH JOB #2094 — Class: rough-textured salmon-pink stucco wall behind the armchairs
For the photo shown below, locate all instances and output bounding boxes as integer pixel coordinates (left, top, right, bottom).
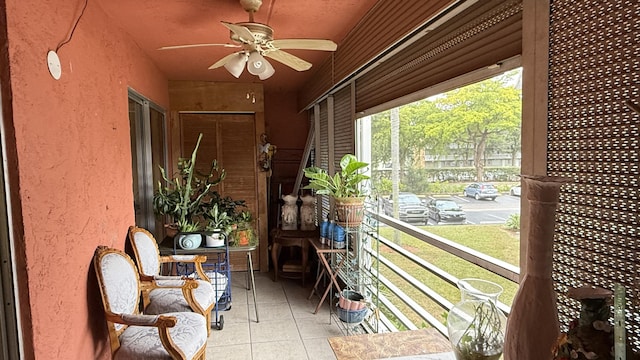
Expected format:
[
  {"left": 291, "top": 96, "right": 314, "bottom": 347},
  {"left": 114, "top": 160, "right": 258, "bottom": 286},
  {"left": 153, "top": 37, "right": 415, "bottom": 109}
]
[{"left": 3, "top": 0, "right": 168, "bottom": 359}]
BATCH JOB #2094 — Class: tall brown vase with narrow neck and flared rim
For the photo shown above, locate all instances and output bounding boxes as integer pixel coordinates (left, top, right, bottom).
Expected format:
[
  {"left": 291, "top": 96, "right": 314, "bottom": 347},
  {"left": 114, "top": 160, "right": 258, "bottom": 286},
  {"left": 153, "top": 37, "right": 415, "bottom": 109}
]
[{"left": 504, "top": 176, "right": 572, "bottom": 360}]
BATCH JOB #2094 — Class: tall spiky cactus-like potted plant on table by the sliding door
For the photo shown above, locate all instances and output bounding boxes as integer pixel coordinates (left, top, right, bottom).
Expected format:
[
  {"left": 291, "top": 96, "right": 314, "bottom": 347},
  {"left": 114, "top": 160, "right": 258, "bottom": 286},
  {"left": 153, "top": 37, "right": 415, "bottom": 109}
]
[{"left": 153, "top": 134, "right": 226, "bottom": 247}]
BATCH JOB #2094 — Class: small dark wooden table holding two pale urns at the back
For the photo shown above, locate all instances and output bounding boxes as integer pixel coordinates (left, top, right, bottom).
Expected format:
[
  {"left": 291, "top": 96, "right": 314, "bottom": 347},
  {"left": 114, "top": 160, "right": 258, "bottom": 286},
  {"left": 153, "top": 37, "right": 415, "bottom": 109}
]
[{"left": 271, "top": 229, "right": 320, "bottom": 287}]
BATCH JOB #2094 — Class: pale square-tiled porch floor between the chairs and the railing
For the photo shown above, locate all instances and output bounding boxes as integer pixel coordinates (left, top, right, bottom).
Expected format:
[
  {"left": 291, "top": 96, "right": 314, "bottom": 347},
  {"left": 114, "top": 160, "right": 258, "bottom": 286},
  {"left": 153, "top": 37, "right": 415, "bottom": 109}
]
[{"left": 207, "top": 272, "right": 343, "bottom": 360}]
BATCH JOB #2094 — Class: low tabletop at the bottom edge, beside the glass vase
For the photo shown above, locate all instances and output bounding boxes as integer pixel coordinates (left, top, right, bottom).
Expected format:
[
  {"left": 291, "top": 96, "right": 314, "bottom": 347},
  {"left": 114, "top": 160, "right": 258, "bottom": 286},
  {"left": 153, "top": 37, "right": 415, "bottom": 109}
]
[{"left": 329, "top": 328, "right": 455, "bottom": 360}]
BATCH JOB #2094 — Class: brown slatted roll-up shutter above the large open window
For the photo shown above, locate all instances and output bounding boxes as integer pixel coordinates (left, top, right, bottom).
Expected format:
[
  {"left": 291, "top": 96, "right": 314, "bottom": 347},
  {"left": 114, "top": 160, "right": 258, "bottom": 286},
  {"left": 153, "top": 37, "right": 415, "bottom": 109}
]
[{"left": 356, "top": 0, "right": 522, "bottom": 112}]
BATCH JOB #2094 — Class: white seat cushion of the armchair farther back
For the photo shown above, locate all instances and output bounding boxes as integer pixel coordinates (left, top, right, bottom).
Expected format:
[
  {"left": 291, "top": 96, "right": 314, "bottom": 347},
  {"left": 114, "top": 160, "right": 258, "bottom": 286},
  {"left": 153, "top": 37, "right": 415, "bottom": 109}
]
[{"left": 144, "top": 280, "right": 216, "bottom": 314}]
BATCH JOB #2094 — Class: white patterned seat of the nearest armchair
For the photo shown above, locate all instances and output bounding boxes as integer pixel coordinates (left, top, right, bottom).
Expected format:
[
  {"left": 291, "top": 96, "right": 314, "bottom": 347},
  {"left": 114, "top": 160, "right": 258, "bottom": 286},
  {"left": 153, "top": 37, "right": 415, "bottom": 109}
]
[{"left": 113, "top": 312, "right": 207, "bottom": 360}]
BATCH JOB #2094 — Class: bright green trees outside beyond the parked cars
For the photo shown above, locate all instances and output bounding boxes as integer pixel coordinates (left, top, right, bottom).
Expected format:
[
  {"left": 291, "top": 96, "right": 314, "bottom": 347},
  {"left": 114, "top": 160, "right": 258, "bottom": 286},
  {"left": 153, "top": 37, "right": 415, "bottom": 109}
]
[{"left": 371, "top": 70, "right": 521, "bottom": 184}]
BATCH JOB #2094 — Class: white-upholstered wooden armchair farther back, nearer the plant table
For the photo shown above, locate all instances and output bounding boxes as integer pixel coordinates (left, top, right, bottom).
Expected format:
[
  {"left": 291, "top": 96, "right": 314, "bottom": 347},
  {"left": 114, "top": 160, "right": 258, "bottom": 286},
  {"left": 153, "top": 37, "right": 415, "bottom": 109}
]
[{"left": 129, "top": 226, "right": 218, "bottom": 328}]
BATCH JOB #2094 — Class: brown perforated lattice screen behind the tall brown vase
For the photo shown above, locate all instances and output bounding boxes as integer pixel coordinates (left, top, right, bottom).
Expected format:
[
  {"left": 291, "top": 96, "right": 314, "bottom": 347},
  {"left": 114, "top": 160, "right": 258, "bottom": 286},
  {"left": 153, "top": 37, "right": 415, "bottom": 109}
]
[{"left": 547, "top": 0, "right": 640, "bottom": 351}]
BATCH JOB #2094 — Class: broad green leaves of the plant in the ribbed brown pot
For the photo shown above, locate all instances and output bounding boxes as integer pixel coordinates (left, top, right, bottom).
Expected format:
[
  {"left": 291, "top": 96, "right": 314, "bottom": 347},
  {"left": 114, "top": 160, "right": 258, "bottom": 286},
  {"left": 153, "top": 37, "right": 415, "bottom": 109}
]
[{"left": 304, "top": 154, "right": 369, "bottom": 198}]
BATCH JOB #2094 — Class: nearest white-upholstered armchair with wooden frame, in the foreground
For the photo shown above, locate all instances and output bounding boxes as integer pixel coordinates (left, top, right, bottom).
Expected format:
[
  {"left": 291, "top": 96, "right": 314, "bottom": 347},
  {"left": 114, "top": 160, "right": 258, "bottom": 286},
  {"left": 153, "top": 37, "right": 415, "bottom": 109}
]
[{"left": 93, "top": 246, "right": 209, "bottom": 360}]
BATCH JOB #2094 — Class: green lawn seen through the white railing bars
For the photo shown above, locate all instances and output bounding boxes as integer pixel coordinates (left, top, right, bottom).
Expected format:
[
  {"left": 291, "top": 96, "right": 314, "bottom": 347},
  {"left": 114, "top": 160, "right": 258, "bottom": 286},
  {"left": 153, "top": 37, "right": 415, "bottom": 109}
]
[{"left": 372, "top": 225, "right": 520, "bottom": 326}]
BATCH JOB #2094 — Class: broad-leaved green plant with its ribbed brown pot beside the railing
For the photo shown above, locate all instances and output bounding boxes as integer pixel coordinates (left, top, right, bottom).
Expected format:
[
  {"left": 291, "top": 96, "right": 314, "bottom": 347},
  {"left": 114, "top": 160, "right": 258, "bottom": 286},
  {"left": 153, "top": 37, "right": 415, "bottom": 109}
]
[{"left": 304, "top": 154, "right": 369, "bottom": 226}]
